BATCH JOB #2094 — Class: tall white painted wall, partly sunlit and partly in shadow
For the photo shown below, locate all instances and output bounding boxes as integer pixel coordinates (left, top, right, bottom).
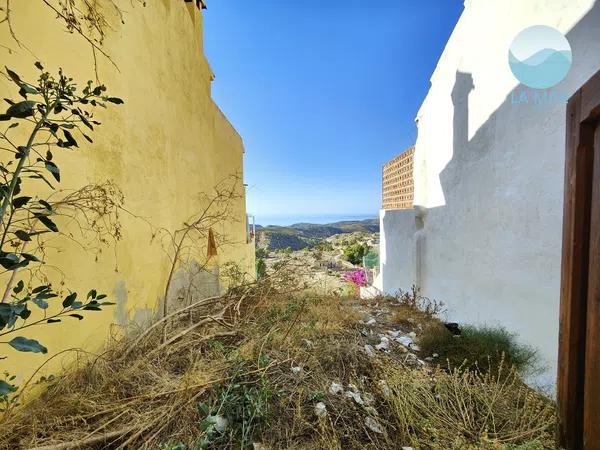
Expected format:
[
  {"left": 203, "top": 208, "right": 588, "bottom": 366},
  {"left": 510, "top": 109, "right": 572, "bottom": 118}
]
[{"left": 380, "top": 0, "right": 600, "bottom": 386}]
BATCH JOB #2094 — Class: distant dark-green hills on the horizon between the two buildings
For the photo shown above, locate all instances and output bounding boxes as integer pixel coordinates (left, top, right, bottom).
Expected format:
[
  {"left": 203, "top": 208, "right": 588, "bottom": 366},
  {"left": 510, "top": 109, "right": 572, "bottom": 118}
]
[{"left": 256, "top": 219, "right": 379, "bottom": 250}]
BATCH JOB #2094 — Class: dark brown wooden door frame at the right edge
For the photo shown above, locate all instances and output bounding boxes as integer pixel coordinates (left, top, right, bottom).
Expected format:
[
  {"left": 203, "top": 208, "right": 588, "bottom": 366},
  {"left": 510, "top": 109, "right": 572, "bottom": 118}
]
[{"left": 557, "top": 72, "right": 600, "bottom": 450}]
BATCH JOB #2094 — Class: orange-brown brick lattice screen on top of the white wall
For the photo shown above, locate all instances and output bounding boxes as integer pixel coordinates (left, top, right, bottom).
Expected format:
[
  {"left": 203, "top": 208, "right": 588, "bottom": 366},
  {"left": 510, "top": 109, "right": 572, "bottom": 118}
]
[{"left": 382, "top": 147, "right": 415, "bottom": 209}]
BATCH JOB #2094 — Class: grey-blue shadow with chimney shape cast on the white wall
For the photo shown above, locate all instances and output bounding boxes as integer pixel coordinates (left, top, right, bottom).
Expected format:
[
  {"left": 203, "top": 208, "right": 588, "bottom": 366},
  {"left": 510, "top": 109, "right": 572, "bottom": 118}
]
[{"left": 382, "top": 2, "right": 600, "bottom": 390}]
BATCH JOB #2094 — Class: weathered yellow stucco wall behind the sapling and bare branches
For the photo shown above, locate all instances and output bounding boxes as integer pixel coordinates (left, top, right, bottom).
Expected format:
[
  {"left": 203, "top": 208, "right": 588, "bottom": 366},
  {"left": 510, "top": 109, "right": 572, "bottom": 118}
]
[{"left": 0, "top": 0, "right": 254, "bottom": 384}]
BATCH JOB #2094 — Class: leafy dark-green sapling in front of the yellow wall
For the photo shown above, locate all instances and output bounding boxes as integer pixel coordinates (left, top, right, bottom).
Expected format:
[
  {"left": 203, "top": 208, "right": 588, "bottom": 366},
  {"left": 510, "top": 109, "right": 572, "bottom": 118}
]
[{"left": 0, "top": 62, "right": 123, "bottom": 401}]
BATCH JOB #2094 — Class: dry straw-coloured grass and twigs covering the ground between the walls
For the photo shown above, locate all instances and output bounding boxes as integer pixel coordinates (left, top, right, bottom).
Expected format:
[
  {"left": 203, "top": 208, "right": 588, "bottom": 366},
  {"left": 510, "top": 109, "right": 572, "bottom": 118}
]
[{"left": 0, "top": 276, "right": 554, "bottom": 450}]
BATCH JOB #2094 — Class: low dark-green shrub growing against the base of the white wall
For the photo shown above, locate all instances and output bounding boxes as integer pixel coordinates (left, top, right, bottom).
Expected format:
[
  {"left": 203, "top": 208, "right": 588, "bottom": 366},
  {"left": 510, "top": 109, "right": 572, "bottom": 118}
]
[{"left": 419, "top": 324, "right": 538, "bottom": 374}]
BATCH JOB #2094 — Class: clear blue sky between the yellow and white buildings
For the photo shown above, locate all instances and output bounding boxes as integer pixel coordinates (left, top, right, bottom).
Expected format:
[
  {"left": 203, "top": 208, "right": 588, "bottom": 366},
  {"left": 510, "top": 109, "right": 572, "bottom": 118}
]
[{"left": 204, "top": 0, "right": 463, "bottom": 223}]
